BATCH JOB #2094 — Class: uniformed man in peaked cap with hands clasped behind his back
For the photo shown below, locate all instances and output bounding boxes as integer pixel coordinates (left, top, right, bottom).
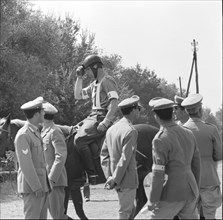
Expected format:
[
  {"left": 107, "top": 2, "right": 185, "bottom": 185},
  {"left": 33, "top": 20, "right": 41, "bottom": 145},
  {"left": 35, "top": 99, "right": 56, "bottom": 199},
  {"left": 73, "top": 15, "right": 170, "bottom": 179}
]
[{"left": 101, "top": 96, "right": 140, "bottom": 219}]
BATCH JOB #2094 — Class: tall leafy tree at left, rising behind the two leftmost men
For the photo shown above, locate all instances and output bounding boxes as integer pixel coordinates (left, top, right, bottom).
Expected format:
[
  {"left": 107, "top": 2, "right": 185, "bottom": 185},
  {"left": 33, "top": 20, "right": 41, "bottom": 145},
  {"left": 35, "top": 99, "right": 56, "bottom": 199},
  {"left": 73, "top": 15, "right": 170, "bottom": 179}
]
[{"left": 0, "top": 0, "right": 96, "bottom": 124}]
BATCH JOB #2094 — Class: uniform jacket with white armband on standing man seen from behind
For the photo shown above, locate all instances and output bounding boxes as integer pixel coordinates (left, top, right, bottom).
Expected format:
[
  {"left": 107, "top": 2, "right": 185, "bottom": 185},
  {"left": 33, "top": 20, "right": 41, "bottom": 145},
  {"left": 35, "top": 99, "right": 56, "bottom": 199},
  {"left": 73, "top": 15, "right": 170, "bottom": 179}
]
[{"left": 150, "top": 122, "right": 200, "bottom": 202}]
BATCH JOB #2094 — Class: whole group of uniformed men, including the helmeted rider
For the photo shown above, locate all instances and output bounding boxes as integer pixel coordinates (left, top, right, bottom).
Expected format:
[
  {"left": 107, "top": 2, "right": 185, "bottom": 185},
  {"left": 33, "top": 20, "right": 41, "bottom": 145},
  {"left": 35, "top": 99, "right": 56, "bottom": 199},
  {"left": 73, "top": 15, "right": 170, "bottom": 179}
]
[{"left": 15, "top": 55, "right": 222, "bottom": 219}]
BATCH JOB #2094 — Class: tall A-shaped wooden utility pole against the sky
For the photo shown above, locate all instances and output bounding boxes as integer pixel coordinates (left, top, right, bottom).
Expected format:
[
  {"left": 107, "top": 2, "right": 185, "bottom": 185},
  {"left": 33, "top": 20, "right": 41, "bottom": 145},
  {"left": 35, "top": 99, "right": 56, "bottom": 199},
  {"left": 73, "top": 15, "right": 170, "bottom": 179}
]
[{"left": 186, "top": 40, "right": 199, "bottom": 97}]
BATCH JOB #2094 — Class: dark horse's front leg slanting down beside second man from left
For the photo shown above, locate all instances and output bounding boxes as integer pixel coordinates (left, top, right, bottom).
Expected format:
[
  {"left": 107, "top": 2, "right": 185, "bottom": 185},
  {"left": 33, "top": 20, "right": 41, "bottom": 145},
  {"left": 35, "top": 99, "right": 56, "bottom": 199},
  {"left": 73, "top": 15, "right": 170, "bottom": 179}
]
[{"left": 70, "top": 187, "right": 88, "bottom": 219}]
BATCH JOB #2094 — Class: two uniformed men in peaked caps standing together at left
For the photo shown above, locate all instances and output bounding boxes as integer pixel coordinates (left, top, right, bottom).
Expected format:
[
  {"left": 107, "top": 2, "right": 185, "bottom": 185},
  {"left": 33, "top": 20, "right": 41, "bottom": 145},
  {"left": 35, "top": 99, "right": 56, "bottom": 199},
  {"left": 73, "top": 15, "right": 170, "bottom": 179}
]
[{"left": 15, "top": 97, "right": 70, "bottom": 219}]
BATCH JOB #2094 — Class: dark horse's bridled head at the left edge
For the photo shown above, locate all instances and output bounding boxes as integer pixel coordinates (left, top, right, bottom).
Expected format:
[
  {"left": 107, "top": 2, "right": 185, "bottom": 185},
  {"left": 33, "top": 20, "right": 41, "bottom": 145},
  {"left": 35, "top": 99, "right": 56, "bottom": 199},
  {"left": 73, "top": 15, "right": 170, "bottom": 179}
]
[{"left": 0, "top": 114, "right": 13, "bottom": 157}]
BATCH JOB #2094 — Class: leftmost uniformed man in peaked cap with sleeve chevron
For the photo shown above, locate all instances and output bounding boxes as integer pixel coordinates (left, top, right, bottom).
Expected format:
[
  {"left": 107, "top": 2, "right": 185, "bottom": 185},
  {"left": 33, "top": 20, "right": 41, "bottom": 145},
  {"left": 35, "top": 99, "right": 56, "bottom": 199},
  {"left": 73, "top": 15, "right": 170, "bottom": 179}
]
[{"left": 15, "top": 97, "right": 50, "bottom": 219}]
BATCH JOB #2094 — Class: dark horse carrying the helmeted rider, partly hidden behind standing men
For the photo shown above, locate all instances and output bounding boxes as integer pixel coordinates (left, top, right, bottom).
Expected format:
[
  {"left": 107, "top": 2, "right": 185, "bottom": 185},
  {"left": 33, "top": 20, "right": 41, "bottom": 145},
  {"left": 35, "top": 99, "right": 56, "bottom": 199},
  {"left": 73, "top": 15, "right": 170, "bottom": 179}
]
[{"left": 0, "top": 116, "right": 158, "bottom": 219}]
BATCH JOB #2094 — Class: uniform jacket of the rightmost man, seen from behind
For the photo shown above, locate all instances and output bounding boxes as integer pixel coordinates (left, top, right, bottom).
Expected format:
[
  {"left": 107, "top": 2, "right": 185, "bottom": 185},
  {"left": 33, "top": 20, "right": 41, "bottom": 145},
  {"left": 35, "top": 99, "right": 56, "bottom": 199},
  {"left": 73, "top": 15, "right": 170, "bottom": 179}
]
[{"left": 184, "top": 118, "right": 222, "bottom": 187}]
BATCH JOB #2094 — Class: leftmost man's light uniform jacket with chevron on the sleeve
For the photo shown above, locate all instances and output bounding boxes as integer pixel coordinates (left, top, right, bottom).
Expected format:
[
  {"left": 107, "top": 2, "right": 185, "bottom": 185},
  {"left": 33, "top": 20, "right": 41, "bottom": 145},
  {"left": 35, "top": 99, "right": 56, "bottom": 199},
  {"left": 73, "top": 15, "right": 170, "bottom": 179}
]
[{"left": 15, "top": 122, "right": 49, "bottom": 193}]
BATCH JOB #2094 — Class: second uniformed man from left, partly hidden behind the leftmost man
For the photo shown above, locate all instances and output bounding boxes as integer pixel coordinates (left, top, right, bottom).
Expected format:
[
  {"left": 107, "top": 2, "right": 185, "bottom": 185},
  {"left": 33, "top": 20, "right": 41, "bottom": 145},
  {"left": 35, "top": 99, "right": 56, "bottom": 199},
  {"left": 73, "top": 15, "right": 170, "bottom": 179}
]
[{"left": 41, "top": 102, "right": 68, "bottom": 219}]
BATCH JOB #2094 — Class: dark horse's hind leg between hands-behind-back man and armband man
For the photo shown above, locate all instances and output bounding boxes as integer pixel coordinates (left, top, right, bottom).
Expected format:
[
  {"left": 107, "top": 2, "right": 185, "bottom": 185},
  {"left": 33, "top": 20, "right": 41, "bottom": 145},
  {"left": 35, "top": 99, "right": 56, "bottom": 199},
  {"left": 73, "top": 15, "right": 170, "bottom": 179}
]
[{"left": 134, "top": 172, "right": 148, "bottom": 218}]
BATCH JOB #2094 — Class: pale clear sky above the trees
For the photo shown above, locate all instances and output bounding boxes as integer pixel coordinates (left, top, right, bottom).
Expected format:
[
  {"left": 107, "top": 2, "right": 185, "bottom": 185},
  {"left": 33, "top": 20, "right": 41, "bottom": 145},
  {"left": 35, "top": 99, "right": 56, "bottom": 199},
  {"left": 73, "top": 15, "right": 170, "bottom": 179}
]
[{"left": 32, "top": 0, "right": 222, "bottom": 113}]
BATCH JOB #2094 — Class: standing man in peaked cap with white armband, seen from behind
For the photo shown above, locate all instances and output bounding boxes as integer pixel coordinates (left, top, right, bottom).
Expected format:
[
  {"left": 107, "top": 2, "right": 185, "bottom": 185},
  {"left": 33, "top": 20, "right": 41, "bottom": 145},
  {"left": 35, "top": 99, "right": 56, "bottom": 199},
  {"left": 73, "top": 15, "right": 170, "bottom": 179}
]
[{"left": 142, "top": 97, "right": 200, "bottom": 219}]
